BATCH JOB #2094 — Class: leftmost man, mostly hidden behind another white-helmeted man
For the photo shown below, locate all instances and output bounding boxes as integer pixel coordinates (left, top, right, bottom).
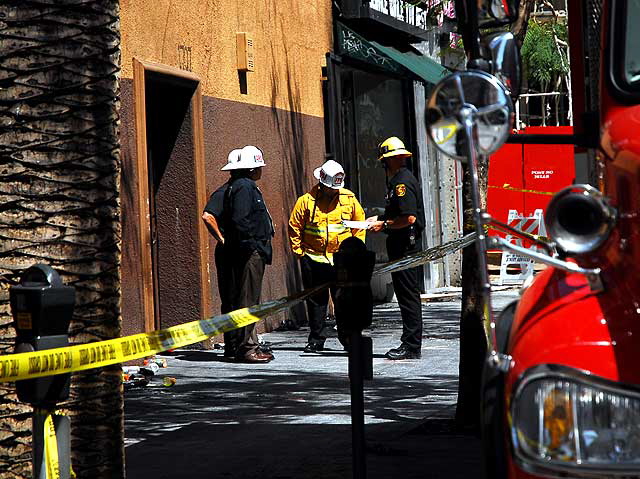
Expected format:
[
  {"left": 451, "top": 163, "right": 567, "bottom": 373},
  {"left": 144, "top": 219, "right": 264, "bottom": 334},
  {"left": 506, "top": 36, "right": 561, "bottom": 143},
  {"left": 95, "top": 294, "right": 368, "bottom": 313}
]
[{"left": 202, "top": 149, "right": 241, "bottom": 359}]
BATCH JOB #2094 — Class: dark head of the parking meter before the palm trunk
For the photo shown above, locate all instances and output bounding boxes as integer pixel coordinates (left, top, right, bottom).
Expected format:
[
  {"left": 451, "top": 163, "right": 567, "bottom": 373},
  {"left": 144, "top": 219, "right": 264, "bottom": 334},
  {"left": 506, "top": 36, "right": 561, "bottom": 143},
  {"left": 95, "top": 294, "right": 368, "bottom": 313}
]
[{"left": 9, "top": 264, "right": 75, "bottom": 406}]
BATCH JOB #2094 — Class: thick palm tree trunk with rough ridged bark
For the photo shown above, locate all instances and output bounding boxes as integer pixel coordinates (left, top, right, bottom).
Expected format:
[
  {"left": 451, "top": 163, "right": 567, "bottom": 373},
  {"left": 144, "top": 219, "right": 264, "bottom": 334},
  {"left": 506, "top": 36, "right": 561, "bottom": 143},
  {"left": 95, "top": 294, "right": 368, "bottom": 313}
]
[{"left": 0, "top": 0, "right": 124, "bottom": 478}]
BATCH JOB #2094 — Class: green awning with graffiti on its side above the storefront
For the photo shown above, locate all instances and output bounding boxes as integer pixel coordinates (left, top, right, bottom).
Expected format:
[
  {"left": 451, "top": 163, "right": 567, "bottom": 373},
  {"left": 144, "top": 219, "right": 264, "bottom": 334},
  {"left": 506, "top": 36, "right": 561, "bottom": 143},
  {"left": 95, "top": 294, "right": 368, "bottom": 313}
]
[{"left": 337, "top": 22, "right": 449, "bottom": 84}]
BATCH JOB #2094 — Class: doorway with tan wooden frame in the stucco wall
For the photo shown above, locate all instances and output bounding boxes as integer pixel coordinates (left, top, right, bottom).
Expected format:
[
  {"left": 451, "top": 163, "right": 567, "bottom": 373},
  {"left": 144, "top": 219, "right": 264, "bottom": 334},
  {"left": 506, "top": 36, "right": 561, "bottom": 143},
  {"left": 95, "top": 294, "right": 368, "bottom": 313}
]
[{"left": 135, "top": 62, "right": 211, "bottom": 331}]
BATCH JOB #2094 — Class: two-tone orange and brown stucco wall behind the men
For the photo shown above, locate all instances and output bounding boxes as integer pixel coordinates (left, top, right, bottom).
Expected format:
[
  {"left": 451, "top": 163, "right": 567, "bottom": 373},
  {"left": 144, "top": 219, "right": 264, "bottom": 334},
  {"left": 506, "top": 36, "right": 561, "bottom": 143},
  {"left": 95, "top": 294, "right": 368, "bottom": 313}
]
[{"left": 121, "top": 0, "right": 331, "bottom": 340}]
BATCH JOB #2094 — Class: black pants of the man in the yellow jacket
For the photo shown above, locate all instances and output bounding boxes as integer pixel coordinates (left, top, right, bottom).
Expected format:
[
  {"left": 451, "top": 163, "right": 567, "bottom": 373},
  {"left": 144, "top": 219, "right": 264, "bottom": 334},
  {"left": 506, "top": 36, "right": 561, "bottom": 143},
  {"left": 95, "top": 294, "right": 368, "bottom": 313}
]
[{"left": 300, "top": 256, "right": 344, "bottom": 344}]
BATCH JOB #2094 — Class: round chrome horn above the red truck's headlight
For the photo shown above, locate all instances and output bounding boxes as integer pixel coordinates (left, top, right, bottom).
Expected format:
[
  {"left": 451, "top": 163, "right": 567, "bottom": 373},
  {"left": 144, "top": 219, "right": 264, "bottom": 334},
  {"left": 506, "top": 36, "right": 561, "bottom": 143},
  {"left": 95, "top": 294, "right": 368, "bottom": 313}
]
[{"left": 545, "top": 185, "right": 616, "bottom": 255}]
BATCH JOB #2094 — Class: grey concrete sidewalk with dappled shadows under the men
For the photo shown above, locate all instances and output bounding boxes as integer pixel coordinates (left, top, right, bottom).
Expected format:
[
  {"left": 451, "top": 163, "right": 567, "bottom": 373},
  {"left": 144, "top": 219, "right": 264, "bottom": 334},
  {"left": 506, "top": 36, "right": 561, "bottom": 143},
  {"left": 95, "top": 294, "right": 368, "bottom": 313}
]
[{"left": 125, "top": 290, "right": 517, "bottom": 479}]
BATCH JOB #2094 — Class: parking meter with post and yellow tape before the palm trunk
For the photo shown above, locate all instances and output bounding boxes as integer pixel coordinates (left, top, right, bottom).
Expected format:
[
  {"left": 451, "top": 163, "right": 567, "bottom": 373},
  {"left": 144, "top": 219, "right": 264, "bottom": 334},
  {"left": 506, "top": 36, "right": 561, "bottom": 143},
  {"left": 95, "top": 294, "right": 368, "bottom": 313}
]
[{"left": 9, "top": 264, "right": 75, "bottom": 479}]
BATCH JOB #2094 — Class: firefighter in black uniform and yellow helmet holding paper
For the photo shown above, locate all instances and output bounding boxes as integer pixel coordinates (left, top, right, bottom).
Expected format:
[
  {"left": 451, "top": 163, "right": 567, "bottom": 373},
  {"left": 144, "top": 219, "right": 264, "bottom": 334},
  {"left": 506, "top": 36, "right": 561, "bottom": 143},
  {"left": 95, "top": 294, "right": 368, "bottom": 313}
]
[{"left": 367, "top": 136, "right": 424, "bottom": 359}]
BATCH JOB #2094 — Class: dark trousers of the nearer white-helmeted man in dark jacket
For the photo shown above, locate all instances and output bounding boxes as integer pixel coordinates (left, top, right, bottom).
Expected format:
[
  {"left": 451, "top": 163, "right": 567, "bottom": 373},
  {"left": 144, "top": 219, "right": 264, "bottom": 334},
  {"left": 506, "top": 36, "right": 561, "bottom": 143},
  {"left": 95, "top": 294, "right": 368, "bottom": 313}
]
[{"left": 225, "top": 251, "right": 265, "bottom": 358}]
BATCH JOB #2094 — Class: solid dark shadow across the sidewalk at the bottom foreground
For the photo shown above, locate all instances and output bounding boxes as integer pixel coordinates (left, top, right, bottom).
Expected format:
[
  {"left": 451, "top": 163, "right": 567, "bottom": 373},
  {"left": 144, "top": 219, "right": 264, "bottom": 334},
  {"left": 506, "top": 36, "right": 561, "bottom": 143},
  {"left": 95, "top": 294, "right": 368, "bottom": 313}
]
[{"left": 127, "top": 422, "right": 480, "bottom": 479}]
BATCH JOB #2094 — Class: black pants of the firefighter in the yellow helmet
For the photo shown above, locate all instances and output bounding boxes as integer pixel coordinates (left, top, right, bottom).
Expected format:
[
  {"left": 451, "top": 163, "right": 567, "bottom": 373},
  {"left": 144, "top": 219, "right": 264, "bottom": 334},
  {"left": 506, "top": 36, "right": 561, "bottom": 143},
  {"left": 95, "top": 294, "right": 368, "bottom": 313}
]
[{"left": 387, "top": 235, "right": 422, "bottom": 350}]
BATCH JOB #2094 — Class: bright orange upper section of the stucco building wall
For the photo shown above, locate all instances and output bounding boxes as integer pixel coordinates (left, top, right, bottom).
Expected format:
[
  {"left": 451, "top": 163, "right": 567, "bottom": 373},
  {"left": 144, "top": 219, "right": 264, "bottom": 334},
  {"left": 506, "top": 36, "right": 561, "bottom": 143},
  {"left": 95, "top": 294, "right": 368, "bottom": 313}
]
[{"left": 121, "top": 0, "right": 331, "bottom": 116}]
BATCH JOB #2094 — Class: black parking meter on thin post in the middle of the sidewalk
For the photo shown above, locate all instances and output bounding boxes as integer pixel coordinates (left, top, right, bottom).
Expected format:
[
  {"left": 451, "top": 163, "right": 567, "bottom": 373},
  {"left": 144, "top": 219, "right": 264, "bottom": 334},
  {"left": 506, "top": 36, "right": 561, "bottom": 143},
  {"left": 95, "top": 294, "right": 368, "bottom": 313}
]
[{"left": 333, "top": 237, "right": 376, "bottom": 479}]
